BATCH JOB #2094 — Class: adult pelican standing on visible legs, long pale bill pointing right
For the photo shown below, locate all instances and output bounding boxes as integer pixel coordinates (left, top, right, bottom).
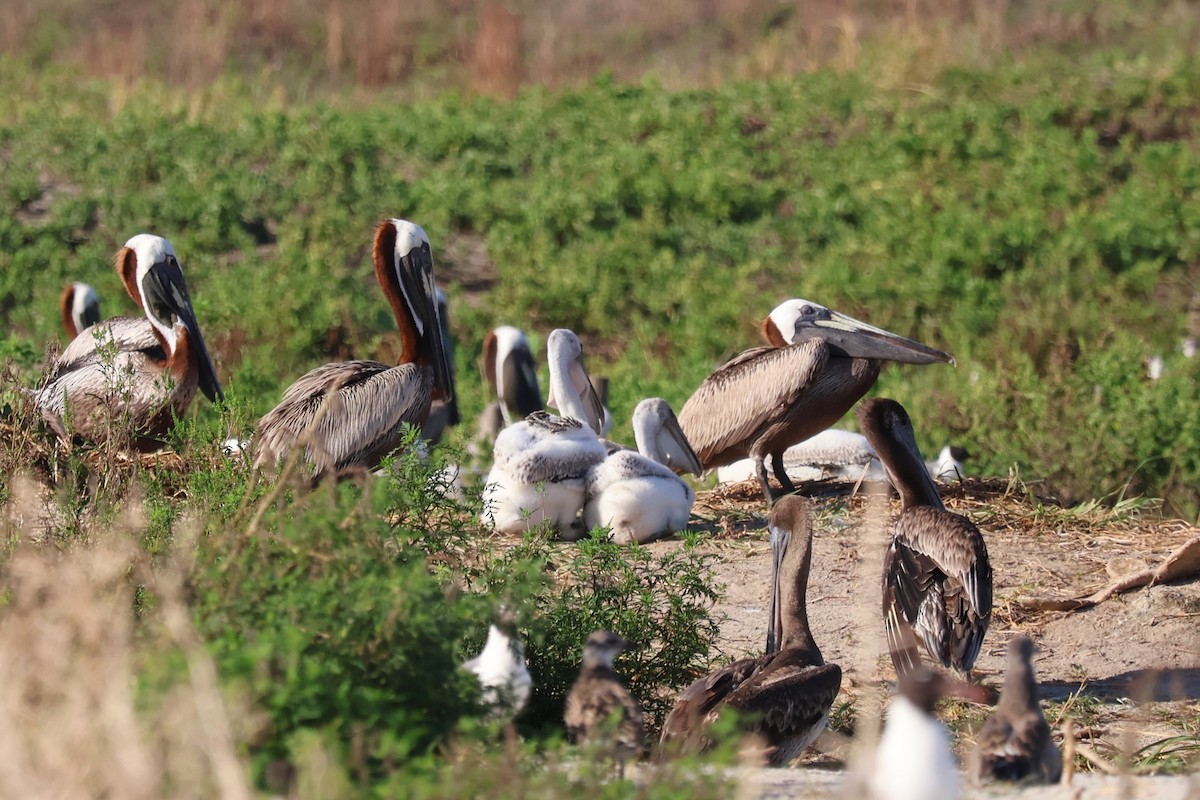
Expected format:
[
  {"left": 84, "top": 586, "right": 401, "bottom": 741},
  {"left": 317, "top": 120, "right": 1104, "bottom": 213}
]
[{"left": 679, "top": 300, "right": 954, "bottom": 500}]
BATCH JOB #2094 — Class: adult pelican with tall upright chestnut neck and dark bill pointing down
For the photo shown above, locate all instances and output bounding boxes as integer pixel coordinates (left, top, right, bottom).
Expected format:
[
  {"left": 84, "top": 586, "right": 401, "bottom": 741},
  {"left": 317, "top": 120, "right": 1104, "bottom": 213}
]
[{"left": 254, "top": 219, "right": 454, "bottom": 482}]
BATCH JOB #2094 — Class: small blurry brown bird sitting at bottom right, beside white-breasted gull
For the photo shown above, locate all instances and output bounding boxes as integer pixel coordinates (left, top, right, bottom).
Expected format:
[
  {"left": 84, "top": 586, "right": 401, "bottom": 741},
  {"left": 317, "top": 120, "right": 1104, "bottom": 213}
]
[{"left": 971, "top": 636, "right": 1062, "bottom": 783}]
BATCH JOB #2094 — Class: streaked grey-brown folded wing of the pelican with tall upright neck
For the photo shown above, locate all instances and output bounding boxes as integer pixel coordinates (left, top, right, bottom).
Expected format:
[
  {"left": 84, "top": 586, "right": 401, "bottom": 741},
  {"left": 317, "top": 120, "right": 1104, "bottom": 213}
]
[{"left": 254, "top": 361, "right": 433, "bottom": 479}]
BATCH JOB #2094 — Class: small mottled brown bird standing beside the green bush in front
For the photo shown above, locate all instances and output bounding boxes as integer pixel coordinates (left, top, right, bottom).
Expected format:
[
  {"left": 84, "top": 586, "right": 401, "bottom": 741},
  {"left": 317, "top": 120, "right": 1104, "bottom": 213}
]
[{"left": 563, "top": 631, "right": 646, "bottom": 775}]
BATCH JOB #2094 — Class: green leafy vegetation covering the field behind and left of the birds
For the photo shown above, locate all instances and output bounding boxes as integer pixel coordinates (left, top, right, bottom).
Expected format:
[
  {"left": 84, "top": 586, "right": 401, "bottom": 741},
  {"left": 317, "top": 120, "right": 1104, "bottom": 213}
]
[{"left": 0, "top": 4, "right": 1200, "bottom": 798}]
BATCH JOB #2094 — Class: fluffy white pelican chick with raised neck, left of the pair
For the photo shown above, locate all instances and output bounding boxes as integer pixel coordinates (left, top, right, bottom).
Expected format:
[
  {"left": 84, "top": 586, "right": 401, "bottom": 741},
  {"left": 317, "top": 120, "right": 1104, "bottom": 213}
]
[{"left": 482, "top": 329, "right": 607, "bottom": 540}]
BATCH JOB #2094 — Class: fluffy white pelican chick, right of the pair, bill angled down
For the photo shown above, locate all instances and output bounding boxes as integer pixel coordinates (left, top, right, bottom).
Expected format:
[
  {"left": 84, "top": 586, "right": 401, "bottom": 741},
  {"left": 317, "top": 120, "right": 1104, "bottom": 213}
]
[{"left": 583, "top": 397, "right": 703, "bottom": 542}]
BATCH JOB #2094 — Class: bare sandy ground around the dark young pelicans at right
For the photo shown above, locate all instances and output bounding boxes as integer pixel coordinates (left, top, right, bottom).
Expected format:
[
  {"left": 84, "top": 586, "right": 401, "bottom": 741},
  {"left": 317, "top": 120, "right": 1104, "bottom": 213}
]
[{"left": 650, "top": 481, "right": 1200, "bottom": 798}]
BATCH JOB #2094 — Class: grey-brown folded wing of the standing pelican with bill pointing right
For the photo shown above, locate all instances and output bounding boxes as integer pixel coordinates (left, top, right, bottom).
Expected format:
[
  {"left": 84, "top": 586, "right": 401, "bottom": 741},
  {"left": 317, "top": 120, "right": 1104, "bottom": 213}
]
[{"left": 679, "top": 339, "right": 829, "bottom": 468}]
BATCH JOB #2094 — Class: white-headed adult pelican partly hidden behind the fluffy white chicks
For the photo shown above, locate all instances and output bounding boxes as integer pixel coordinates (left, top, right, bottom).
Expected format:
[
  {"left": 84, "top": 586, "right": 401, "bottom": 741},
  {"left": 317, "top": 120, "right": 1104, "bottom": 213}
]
[{"left": 479, "top": 325, "right": 544, "bottom": 441}]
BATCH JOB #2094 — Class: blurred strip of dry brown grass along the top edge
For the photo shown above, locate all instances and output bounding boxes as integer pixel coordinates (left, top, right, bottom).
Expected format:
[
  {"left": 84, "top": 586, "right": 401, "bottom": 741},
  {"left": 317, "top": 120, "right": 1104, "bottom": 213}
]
[{"left": 0, "top": 0, "right": 1195, "bottom": 95}]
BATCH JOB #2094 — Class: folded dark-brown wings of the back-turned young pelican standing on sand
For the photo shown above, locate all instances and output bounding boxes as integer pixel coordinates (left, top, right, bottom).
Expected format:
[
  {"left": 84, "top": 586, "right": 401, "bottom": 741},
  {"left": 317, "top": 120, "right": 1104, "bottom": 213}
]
[{"left": 884, "top": 506, "right": 992, "bottom": 669}]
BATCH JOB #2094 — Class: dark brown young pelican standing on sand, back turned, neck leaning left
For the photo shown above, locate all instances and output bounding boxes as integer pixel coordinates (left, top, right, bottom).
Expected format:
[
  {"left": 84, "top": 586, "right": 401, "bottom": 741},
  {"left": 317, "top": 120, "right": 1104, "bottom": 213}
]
[{"left": 858, "top": 397, "right": 991, "bottom": 674}]
